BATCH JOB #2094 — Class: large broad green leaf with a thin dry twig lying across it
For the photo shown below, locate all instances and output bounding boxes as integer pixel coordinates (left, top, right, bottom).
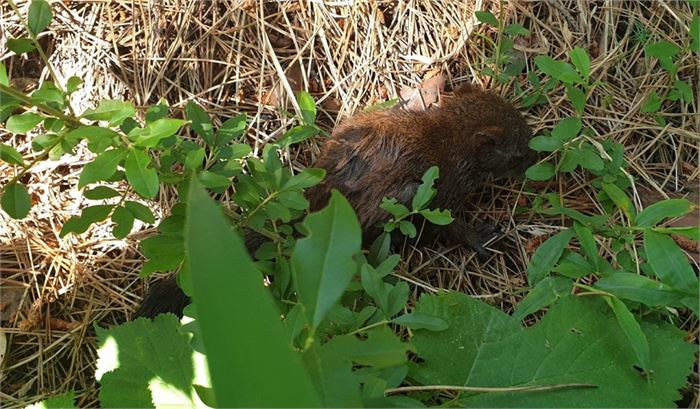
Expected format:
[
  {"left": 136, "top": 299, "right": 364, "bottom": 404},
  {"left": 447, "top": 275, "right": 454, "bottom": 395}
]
[{"left": 410, "top": 293, "right": 697, "bottom": 408}]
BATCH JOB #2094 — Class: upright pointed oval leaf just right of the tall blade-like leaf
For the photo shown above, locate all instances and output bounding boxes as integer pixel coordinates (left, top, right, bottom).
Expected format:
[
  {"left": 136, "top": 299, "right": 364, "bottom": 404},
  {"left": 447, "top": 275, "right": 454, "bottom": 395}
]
[{"left": 292, "top": 190, "right": 362, "bottom": 328}]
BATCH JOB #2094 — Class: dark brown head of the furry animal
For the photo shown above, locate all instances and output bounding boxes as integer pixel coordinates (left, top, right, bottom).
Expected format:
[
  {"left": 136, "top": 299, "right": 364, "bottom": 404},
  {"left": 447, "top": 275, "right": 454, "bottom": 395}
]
[{"left": 450, "top": 85, "right": 536, "bottom": 177}]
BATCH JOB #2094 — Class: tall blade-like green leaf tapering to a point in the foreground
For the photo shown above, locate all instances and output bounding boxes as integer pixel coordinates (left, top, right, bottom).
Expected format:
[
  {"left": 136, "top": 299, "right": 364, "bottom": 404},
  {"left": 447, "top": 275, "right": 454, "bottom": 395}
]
[{"left": 185, "top": 178, "right": 318, "bottom": 407}]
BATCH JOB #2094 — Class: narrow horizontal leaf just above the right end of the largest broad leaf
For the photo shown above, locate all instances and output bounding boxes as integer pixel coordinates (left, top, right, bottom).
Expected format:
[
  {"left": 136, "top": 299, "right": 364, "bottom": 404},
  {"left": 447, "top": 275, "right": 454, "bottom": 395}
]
[{"left": 595, "top": 272, "right": 683, "bottom": 307}]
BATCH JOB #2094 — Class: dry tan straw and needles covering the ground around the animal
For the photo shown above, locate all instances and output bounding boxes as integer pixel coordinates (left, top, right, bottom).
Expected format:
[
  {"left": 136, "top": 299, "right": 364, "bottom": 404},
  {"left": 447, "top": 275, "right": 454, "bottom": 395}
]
[{"left": 0, "top": 0, "right": 700, "bottom": 407}]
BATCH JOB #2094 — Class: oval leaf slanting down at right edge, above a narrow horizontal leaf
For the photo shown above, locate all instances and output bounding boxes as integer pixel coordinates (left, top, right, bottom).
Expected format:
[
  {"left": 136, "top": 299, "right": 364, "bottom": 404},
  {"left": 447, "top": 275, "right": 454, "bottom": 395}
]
[{"left": 644, "top": 229, "right": 698, "bottom": 294}]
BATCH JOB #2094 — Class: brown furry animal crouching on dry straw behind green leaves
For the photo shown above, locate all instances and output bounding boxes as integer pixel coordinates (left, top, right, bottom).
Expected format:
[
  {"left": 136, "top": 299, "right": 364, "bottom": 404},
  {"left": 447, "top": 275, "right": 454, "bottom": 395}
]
[{"left": 136, "top": 85, "right": 535, "bottom": 317}]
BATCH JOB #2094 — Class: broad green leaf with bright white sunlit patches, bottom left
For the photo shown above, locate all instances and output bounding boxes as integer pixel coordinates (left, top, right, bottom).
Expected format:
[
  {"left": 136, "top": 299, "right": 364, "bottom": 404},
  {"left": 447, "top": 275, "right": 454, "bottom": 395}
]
[{"left": 95, "top": 314, "right": 198, "bottom": 408}]
